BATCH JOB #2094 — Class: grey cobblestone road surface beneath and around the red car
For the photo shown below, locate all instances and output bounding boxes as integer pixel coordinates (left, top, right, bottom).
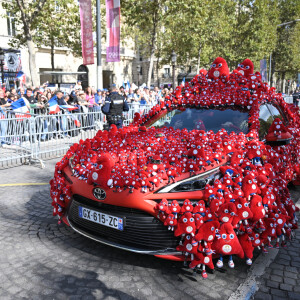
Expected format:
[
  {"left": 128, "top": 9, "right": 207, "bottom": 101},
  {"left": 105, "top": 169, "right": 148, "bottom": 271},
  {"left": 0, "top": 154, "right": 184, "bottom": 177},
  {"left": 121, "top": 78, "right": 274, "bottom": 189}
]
[{"left": 0, "top": 159, "right": 300, "bottom": 300}]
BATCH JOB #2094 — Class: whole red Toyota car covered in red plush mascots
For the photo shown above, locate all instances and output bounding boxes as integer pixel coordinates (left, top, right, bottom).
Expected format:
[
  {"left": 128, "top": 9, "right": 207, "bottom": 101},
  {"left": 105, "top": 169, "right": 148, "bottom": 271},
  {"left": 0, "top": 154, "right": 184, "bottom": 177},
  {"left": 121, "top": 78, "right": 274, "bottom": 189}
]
[{"left": 50, "top": 57, "right": 300, "bottom": 277}]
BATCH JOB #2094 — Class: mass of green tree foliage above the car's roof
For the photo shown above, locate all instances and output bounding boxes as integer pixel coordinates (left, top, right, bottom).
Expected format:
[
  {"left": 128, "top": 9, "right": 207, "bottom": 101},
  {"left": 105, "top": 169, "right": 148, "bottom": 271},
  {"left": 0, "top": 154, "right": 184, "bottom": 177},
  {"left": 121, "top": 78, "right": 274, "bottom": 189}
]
[{"left": 121, "top": 0, "right": 290, "bottom": 69}]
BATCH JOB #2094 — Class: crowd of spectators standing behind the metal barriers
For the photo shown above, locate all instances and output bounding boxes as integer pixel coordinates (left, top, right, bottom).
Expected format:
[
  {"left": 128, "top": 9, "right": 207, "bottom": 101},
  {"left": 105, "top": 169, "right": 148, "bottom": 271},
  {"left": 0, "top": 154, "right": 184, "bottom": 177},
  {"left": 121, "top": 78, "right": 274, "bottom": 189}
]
[{"left": 0, "top": 81, "right": 172, "bottom": 114}]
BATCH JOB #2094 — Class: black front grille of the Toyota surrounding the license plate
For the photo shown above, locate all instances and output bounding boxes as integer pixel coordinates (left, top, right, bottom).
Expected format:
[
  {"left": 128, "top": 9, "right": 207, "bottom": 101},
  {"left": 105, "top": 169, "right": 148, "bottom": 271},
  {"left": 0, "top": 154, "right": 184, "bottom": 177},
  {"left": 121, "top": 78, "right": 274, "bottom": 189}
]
[{"left": 68, "top": 195, "right": 179, "bottom": 251}]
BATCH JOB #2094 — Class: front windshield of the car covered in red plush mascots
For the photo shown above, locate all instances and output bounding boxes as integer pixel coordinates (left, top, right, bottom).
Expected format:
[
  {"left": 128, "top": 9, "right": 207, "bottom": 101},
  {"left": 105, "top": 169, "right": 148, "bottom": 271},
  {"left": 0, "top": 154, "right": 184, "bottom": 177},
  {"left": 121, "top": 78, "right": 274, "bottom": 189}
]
[{"left": 152, "top": 108, "right": 249, "bottom": 133}]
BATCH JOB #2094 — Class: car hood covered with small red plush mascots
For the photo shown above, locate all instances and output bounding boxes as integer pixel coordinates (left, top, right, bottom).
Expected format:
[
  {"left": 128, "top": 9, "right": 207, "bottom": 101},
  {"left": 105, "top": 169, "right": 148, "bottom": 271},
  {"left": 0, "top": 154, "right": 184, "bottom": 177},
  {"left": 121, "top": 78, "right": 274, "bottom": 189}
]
[{"left": 61, "top": 126, "right": 241, "bottom": 192}]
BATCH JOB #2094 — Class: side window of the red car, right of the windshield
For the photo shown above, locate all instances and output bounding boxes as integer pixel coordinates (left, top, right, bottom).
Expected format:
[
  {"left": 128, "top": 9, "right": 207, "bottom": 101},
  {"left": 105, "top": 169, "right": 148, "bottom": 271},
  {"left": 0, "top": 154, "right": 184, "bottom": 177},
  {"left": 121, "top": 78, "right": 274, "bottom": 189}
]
[{"left": 259, "top": 104, "right": 286, "bottom": 140}]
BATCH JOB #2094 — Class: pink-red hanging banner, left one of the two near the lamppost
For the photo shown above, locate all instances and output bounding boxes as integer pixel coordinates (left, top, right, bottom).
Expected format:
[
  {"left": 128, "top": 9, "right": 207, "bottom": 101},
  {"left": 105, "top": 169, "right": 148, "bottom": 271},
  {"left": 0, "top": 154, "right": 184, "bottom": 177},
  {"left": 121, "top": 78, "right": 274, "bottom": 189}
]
[{"left": 79, "top": 0, "right": 94, "bottom": 65}]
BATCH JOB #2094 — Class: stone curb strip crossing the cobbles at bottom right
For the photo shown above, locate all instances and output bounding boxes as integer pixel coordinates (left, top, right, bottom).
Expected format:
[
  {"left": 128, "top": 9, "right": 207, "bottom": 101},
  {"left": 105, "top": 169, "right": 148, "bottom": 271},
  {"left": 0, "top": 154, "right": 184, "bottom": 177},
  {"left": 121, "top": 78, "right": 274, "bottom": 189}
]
[{"left": 228, "top": 199, "right": 300, "bottom": 300}]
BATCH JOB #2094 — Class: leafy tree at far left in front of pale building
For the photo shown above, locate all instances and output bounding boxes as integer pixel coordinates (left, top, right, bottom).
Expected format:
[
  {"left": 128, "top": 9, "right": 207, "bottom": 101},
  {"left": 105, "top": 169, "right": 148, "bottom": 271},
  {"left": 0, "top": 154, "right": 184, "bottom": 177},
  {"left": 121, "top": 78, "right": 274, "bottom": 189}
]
[{"left": 3, "top": 0, "right": 81, "bottom": 86}]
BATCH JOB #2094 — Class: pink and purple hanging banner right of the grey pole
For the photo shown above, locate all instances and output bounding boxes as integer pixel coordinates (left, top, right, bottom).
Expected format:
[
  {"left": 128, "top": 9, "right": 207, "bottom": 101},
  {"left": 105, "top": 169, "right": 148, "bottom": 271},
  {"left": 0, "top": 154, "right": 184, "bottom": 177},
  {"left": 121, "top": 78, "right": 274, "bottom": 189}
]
[{"left": 106, "top": 0, "right": 120, "bottom": 62}]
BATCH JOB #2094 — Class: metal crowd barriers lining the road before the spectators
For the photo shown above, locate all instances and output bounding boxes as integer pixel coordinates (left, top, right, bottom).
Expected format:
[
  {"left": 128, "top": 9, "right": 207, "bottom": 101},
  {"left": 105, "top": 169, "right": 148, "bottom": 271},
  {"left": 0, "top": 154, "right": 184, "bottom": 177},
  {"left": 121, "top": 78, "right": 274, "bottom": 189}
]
[{"left": 0, "top": 104, "right": 152, "bottom": 168}]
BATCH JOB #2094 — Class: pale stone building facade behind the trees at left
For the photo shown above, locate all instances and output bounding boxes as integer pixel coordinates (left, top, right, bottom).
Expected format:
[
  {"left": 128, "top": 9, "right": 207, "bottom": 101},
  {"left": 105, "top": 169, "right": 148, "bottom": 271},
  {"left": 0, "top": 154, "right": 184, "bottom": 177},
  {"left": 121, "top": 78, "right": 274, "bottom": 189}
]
[{"left": 0, "top": 1, "right": 135, "bottom": 88}]
